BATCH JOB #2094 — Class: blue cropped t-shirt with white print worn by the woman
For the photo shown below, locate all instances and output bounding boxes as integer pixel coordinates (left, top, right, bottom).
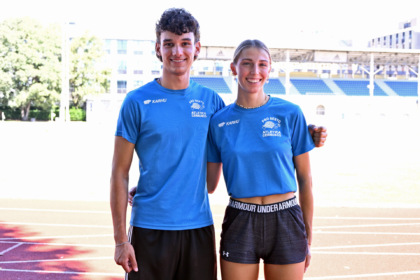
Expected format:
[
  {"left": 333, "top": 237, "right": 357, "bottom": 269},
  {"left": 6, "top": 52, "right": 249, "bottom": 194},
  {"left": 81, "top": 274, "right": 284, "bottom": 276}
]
[{"left": 208, "top": 97, "right": 314, "bottom": 198}]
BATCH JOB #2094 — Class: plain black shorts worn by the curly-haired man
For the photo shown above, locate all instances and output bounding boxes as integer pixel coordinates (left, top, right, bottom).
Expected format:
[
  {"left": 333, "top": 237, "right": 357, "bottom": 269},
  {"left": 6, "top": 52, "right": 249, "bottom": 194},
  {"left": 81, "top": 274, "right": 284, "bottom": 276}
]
[{"left": 126, "top": 225, "right": 217, "bottom": 280}]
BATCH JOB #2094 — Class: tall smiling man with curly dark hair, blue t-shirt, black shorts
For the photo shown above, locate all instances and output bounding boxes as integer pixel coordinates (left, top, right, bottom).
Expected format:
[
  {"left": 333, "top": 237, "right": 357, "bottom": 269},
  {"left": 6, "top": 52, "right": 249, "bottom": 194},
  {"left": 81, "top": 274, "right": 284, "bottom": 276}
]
[{"left": 111, "top": 6, "right": 326, "bottom": 280}]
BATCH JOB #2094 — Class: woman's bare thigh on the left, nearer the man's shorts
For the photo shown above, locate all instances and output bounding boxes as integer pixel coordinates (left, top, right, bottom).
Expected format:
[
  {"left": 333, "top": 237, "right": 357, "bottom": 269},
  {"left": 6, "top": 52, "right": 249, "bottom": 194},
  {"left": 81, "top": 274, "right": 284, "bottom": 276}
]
[{"left": 220, "top": 258, "right": 260, "bottom": 280}]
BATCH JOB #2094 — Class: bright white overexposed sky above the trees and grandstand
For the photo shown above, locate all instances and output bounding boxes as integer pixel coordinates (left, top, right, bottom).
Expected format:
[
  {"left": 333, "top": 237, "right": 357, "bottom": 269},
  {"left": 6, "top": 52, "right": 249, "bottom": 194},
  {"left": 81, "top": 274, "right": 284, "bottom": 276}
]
[{"left": 0, "top": 0, "right": 420, "bottom": 48}]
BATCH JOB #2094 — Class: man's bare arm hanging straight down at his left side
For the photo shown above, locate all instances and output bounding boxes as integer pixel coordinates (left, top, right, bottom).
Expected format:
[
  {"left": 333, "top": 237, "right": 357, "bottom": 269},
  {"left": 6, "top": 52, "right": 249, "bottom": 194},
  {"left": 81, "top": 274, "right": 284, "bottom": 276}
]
[{"left": 110, "top": 136, "right": 138, "bottom": 273}]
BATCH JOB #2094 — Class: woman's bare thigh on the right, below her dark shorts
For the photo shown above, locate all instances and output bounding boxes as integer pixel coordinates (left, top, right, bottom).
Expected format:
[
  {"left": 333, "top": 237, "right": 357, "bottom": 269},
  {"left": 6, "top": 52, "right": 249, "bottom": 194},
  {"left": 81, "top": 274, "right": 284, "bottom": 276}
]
[{"left": 264, "top": 262, "right": 305, "bottom": 280}]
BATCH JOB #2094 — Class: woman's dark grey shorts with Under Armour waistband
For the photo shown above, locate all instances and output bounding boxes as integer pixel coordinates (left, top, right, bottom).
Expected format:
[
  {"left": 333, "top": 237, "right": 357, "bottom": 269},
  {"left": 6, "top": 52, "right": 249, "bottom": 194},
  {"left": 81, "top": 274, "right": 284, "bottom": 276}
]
[{"left": 220, "top": 197, "right": 308, "bottom": 265}]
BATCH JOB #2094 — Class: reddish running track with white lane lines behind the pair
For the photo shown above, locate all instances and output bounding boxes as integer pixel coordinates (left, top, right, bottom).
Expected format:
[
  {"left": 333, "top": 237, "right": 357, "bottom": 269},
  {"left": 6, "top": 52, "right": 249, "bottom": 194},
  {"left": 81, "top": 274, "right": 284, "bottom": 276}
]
[{"left": 0, "top": 199, "right": 420, "bottom": 280}]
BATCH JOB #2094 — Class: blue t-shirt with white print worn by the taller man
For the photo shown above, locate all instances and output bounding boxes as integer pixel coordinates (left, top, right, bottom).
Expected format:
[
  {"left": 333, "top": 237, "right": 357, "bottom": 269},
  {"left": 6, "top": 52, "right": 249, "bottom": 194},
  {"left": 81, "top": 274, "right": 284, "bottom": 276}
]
[{"left": 115, "top": 80, "right": 224, "bottom": 230}]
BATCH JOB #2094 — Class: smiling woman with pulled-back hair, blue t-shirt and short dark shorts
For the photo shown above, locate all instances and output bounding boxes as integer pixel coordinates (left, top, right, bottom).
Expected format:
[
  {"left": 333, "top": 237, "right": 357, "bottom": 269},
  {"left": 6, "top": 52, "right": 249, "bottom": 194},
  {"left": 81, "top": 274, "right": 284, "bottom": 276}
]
[{"left": 208, "top": 40, "right": 315, "bottom": 280}]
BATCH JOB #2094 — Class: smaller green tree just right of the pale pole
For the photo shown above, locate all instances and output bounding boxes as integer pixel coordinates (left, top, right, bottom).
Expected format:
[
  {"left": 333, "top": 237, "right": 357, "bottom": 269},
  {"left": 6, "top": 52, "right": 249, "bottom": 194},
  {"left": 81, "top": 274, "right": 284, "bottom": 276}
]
[{"left": 70, "top": 33, "right": 111, "bottom": 108}]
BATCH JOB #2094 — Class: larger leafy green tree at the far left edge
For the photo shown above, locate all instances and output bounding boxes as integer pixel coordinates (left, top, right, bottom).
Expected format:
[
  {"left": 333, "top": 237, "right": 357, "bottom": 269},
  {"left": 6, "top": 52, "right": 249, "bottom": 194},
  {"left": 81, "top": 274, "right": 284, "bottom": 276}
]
[{"left": 0, "top": 18, "right": 61, "bottom": 120}]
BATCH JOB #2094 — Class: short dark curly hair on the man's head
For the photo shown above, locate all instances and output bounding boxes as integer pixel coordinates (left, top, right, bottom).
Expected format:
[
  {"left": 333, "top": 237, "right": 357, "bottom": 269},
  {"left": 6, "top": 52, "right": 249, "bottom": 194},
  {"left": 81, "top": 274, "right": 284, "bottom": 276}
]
[{"left": 156, "top": 8, "right": 200, "bottom": 61}]
